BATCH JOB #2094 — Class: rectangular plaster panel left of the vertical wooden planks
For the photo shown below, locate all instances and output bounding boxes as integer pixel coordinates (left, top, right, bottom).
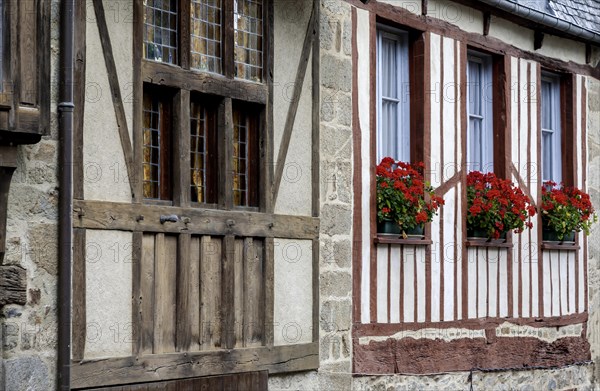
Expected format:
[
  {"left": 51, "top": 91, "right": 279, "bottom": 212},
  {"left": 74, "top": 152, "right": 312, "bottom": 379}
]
[{"left": 84, "top": 229, "right": 132, "bottom": 359}]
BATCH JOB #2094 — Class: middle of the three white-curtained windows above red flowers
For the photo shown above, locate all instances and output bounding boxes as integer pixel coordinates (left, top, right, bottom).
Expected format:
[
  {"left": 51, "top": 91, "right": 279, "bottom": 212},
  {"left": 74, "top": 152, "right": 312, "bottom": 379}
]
[{"left": 467, "top": 51, "right": 494, "bottom": 172}]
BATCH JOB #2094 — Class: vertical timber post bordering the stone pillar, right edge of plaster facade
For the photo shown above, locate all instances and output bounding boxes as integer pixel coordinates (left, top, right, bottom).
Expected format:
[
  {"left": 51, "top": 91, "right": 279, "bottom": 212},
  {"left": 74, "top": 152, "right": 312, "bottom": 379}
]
[{"left": 311, "top": 0, "right": 322, "bottom": 342}]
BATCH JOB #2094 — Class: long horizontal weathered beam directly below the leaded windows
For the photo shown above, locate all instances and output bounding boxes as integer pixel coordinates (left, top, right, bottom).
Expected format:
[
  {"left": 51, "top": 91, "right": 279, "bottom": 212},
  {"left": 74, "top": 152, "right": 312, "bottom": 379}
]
[{"left": 73, "top": 200, "right": 319, "bottom": 240}]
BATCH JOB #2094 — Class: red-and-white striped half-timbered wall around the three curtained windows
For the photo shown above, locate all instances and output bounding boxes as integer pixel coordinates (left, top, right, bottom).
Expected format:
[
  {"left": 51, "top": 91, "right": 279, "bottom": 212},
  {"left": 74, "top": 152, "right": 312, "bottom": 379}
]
[{"left": 348, "top": 0, "right": 591, "bottom": 373}]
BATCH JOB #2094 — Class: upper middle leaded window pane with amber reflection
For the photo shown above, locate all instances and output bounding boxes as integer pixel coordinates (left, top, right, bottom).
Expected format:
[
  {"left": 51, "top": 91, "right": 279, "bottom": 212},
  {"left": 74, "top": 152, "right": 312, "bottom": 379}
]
[{"left": 190, "top": 0, "right": 222, "bottom": 73}]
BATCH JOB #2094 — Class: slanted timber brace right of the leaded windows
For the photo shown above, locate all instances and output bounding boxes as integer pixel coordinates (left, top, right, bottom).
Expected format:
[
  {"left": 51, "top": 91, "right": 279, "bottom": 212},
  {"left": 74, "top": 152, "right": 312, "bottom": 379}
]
[{"left": 273, "top": 7, "right": 317, "bottom": 202}]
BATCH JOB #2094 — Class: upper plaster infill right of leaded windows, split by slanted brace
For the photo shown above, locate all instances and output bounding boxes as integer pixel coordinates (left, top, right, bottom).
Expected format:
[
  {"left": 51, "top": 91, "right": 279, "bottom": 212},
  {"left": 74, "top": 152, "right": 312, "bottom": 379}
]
[{"left": 273, "top": 0, "right": 312, "bottom": 215}]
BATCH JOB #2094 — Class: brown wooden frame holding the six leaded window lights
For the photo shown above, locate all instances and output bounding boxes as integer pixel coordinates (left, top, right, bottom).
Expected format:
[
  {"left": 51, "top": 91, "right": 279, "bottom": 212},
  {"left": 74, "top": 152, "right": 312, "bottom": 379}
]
[{"left": 134, "top": 0, "right": 272, "bottom": 212}]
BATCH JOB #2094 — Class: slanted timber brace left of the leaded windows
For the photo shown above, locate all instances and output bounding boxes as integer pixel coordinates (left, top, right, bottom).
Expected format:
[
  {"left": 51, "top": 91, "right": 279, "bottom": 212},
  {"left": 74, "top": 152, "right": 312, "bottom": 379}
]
[{"left": 93, "top": 0, "right": 135, "bottom": 197}]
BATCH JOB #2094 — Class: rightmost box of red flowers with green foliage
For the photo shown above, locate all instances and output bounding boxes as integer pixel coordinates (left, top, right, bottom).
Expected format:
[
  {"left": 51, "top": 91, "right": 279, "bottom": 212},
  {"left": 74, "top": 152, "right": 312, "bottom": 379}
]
[{"left": 541, "top": 181, "right": 598, "bottom": 242}]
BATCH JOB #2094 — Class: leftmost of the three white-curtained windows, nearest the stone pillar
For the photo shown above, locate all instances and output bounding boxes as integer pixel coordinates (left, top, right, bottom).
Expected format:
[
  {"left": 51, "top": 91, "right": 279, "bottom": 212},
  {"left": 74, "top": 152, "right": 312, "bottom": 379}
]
[{"left": 377, "top": 26, "right": 410, "bottom": 162}]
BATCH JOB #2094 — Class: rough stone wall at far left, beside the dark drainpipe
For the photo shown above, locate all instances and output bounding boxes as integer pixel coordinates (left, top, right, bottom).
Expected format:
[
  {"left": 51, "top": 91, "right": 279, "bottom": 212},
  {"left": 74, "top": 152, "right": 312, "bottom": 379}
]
[{"left": 0, "top": 0, "right": 59, "bottom": 391}]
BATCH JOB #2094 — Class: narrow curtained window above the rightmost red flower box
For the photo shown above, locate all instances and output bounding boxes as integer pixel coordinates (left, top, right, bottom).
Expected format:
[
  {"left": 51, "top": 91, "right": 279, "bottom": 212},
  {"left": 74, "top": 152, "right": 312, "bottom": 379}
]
[{"left": 541, "top": 72, "right": 562, "bottom": 183}]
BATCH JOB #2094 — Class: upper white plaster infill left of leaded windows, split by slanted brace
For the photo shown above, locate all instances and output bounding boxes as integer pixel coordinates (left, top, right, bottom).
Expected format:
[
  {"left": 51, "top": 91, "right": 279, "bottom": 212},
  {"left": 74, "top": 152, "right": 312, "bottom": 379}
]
[{"left": 83, "top": 0, "right": 133, "bottom": 202}]
